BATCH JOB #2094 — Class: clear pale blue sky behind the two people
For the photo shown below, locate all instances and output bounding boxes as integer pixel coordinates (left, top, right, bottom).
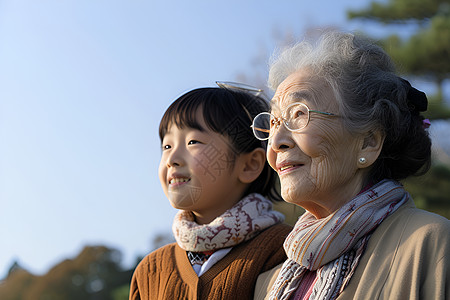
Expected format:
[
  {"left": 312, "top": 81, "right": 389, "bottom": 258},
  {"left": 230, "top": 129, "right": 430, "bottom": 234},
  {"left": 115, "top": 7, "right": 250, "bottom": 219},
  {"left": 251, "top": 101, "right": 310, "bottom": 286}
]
[{"left": 0, "top": 0, "right": 450, "bottom": 278}]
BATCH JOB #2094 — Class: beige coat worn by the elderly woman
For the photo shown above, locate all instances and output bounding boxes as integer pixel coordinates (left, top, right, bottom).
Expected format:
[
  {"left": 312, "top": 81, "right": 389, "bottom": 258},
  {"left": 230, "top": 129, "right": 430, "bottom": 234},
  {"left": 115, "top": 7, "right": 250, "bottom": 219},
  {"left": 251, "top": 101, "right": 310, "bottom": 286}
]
[{"left": 254, "top": 200, "right": 450, "bottom": 300}]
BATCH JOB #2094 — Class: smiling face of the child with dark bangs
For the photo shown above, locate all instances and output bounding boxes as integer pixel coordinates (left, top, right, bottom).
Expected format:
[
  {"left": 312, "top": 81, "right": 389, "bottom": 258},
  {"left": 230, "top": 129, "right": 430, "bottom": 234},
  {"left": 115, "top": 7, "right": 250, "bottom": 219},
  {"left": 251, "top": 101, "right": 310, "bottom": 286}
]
[{"left": 159, "top": 109, "right": 243, "bottom": 221}]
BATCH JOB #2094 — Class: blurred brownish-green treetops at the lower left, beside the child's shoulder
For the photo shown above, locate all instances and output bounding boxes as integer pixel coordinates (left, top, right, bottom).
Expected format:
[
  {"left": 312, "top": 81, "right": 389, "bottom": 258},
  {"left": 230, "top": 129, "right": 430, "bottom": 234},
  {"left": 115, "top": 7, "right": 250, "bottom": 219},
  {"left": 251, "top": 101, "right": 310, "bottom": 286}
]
[{"left": 0, "top": 246, "right": 133, "bottom": 300}]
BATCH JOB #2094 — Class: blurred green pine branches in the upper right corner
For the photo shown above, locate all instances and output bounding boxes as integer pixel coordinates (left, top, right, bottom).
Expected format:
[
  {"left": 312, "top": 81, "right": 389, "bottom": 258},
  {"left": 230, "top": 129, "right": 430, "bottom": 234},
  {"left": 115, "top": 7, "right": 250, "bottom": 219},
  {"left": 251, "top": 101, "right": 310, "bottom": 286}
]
[{"left": 348, "top": 0, "right": 450, "bottom": 119}]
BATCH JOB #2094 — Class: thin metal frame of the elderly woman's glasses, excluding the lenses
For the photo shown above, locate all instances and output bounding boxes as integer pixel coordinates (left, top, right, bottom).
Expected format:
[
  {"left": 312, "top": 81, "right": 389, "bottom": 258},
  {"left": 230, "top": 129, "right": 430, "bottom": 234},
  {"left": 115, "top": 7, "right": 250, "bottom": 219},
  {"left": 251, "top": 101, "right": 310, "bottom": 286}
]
[{"left": 250, "top": 102, "right": 338, "bottom": 141}]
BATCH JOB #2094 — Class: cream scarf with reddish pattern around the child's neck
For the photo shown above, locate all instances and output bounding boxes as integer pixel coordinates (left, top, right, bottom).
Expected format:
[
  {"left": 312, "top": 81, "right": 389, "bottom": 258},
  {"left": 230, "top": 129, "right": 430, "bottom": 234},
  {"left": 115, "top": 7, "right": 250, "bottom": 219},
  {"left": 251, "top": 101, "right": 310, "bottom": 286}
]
[{"left": 172, "top": 194, "right": 284, "bottom": 252}]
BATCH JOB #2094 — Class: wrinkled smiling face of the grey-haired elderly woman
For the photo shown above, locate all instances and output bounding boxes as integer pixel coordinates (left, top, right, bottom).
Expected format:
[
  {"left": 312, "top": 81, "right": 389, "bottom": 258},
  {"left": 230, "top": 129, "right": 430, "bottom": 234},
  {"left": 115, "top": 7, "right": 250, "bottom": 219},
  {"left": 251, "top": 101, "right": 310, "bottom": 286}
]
[{"left": 267, "top": 69, "right": 362, "bottom": 217}]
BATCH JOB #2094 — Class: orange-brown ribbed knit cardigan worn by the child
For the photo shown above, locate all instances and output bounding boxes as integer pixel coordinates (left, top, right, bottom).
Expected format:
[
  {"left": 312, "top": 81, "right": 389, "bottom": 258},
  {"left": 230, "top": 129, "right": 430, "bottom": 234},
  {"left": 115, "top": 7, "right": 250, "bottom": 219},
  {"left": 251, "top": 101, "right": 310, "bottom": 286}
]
[{"left": 130, "top": 224, "right": 292, "bottom": 300}]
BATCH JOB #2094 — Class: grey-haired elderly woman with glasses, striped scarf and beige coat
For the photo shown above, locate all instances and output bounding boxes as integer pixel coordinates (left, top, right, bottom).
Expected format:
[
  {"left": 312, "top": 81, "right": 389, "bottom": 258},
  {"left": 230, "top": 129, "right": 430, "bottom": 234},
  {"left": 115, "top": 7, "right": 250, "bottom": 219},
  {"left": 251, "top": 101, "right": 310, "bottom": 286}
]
[{"left": 252, "top": 32, "right": 450, "bottom": 299}]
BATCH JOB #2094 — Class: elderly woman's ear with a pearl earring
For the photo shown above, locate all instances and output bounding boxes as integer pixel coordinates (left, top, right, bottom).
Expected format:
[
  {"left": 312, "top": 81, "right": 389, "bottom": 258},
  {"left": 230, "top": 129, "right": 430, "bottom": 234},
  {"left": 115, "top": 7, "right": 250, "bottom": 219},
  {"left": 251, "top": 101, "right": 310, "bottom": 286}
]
[{"left": 358, "top": 130, "right": 385, "bottom": 169}]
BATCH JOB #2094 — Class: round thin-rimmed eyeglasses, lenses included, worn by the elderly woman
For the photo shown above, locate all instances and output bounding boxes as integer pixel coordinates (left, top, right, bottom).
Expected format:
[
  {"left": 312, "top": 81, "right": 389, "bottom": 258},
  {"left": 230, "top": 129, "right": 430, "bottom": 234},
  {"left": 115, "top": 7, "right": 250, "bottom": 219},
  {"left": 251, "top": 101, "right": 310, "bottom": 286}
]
[{"left": 251, "top": 102, "right": 337, "bottom": 141}]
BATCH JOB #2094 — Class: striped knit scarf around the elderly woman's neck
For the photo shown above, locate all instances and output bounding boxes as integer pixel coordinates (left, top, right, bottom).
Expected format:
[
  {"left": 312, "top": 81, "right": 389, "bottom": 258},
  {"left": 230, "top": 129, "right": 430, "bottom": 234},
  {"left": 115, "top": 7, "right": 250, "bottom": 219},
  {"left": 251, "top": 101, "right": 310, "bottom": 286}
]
[{"left": 270, "top": 180, "right": 409, "bottom": 300}]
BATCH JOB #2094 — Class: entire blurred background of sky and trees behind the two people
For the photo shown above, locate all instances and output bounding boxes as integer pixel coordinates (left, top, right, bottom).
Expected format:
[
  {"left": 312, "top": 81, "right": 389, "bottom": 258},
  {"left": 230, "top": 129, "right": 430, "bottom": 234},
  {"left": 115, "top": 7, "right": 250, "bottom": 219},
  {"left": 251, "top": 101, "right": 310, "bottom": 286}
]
[{"left": 0, "top": 0, "right": 450, "bottom": 300}]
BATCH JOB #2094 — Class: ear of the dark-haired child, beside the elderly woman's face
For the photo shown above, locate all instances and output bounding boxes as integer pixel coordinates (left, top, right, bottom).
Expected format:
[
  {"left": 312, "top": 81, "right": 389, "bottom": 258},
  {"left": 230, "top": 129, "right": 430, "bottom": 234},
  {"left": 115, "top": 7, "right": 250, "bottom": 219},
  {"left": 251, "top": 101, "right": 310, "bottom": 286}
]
[{"left": 238, "top": 148, "right": 266, "bottom": 183}]
